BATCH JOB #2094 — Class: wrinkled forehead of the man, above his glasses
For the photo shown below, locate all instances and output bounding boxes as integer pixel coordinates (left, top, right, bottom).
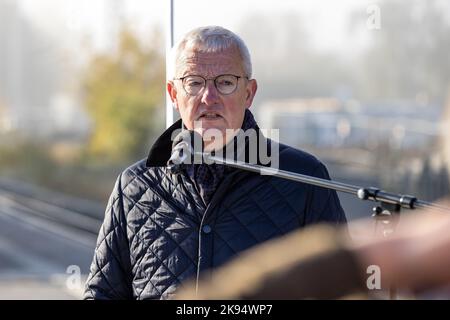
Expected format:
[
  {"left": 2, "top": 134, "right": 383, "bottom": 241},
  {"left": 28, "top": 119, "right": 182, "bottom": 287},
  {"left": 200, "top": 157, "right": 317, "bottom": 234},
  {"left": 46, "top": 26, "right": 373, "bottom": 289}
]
[{"left": 176, "top": 48, "right": 243, "bottom": 77}]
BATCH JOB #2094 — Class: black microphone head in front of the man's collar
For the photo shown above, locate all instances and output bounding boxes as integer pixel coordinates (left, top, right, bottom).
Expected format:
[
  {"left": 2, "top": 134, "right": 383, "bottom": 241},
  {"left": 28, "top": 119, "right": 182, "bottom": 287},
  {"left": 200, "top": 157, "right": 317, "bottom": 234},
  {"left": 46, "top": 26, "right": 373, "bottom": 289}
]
[{"left": 167, "top": 130, "right": 203, "bottom": 174}]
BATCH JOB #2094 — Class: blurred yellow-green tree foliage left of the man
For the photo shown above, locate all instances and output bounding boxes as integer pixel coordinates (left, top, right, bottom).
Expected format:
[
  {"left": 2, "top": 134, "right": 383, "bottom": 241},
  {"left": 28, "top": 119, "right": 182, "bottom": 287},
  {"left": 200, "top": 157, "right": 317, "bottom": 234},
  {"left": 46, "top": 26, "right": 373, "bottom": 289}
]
[{"left": 83, "top": 30, "right": 165, "bottom": 162}]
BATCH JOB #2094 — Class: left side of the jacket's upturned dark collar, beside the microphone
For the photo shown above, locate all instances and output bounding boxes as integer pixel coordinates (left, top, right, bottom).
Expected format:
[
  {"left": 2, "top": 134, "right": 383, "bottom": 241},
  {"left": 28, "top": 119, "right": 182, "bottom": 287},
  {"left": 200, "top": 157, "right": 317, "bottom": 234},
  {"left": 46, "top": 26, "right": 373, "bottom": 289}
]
[{"left": 146, "top": 119, "right": 182, "bottom": 167}]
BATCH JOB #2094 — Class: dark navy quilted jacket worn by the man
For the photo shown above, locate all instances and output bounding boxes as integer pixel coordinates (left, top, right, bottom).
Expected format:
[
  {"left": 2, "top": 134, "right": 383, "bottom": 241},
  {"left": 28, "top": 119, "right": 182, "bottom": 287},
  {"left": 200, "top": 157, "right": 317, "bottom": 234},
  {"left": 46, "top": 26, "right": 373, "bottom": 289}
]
[{"left": 84, "top": 122, "right": 346, "bottom": 299}]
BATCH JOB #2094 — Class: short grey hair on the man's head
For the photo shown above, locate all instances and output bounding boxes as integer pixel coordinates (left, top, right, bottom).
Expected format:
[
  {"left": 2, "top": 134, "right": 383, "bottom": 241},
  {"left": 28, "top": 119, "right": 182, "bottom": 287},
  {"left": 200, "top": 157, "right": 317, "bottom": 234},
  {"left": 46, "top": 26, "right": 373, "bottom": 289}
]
[{"left": 169, "top": 26, "right": 252, "bottom": 78}]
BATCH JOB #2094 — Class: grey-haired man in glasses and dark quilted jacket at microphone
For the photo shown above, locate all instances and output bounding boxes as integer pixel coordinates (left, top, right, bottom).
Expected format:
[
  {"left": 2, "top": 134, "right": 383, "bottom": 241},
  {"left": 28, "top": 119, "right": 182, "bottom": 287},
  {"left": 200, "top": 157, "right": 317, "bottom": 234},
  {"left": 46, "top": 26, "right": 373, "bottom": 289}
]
[{"left": 85, "top": 27, "right": 346, "bottom": 299}]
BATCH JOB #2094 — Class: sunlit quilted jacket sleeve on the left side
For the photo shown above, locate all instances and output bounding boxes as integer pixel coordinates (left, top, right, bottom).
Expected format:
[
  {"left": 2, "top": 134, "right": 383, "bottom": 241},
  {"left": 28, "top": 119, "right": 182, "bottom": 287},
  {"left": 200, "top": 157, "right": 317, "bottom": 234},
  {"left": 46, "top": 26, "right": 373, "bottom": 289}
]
[{"left": 84, "top": 176, "right": 132, "bottom": 299}]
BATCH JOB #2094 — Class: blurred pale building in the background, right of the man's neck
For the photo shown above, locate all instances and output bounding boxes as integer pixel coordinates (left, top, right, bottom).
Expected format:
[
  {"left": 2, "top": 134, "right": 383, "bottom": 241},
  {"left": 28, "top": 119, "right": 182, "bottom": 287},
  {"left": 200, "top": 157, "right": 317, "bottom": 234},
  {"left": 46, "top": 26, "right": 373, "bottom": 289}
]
[{"left": 258, "top": 97, "right": 442, "bottom": 149}]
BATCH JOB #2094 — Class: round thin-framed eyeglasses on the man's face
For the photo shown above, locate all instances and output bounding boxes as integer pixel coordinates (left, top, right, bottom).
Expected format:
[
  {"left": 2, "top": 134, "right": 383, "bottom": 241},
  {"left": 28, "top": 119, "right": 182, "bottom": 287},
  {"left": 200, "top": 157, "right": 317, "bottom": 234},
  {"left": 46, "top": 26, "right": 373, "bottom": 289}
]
[{"left": 174, "top": 74, "right": 248, "bottom": 96}]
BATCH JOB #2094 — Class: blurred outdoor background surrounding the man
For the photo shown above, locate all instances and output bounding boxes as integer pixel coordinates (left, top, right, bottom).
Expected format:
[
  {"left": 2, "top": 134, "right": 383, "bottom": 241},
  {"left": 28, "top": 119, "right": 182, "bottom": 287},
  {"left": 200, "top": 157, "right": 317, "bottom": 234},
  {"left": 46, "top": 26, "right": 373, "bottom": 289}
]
[{"left": 0, "top": 0, "right": 450, "bottom": 299}]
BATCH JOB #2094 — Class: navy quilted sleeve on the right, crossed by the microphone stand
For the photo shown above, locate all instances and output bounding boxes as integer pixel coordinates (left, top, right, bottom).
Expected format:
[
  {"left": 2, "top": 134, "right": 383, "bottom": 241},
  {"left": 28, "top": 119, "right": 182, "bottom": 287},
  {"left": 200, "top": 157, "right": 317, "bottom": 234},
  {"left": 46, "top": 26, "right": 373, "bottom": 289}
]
[{"left": 305, "top": 162, "right": 347, "bottom": 224}]
